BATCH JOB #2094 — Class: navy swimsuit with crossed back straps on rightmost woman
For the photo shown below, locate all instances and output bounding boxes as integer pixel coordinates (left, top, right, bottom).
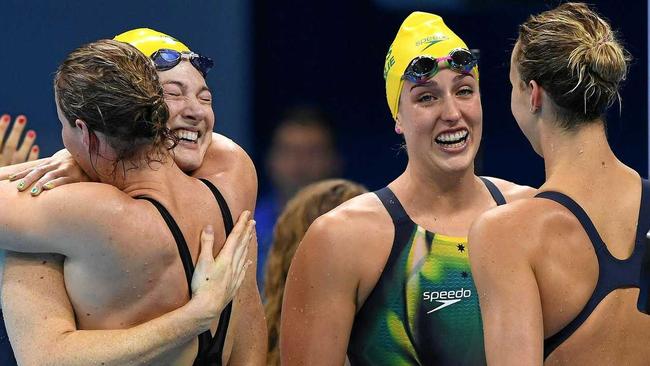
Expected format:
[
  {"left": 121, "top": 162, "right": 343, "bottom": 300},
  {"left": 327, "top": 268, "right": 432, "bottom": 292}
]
[{"left": 535, "top": 179, "right": 650, "bottom": 359}]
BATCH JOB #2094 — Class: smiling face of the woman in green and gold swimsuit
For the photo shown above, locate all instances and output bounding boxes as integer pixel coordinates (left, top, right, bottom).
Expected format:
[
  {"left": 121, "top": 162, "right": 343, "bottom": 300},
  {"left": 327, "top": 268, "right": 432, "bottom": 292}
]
[{"left": 397, "top": 69, "right": 483, "bottom": 177}]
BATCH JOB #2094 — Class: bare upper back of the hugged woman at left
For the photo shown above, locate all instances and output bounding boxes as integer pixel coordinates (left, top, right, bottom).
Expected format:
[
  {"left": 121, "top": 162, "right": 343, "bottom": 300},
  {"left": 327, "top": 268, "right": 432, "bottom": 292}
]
[{"left": 36, "top": 176, "right": 225, "bottom": 329}]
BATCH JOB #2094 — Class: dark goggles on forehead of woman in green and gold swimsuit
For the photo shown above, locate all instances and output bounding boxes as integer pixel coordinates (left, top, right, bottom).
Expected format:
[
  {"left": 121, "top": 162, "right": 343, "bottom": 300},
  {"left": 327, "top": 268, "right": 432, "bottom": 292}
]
[{"left": 402, "top": 48, "right": 478, "bottom": 83}]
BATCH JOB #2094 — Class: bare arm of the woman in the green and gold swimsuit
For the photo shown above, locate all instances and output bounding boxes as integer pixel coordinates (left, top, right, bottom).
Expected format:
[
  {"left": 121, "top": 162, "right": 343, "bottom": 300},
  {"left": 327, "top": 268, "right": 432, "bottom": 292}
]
[{"left": 280, "top": 215, "right": 359, "bottom": 365}]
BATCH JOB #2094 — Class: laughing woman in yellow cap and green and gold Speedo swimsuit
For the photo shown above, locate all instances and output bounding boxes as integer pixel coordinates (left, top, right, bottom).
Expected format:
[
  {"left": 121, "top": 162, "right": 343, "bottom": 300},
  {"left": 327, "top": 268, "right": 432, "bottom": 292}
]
[{"left": 280, "top": 12, "right": 533, "bottom": 365}]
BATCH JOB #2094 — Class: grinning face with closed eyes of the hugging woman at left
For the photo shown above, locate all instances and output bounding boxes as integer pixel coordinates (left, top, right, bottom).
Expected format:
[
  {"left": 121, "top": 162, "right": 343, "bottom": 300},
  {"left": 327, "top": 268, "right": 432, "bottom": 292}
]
[{"left": 158, "top": 61, "right": 214, "bottom": 173}]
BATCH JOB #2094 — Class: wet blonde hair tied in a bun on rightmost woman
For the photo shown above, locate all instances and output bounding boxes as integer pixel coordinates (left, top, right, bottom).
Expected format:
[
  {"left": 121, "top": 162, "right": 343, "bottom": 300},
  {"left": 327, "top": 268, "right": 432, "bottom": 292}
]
[{"left": 513, "top": 3, "right": 630, "bottom": 130}]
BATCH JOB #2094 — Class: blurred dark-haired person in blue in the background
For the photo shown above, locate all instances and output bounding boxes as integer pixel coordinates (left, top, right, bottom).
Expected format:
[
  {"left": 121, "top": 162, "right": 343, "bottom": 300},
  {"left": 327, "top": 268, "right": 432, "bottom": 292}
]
[{"left": 255, "top": 106, "right": 341, "bottom": 290}]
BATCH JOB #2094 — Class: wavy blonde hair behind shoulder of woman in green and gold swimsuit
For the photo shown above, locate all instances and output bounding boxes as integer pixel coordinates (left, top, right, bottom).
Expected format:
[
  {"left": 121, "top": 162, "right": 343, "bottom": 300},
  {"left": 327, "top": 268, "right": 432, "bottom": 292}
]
[{"left": 264, "top": 179, "right": 368, "bottom": 365}]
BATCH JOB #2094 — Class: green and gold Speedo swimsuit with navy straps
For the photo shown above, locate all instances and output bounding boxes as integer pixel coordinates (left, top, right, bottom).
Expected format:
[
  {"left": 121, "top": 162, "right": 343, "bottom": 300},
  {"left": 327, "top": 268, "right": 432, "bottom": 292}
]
[{"left": 348, "top": 178, "right": 505, "bottom": 366}]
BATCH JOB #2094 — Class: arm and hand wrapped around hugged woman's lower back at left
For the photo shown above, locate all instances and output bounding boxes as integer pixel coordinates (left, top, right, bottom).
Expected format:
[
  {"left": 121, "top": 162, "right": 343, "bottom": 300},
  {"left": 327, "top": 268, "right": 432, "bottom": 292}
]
[{"left": 2, "top": 214, "right": 253, "bottom": 365}]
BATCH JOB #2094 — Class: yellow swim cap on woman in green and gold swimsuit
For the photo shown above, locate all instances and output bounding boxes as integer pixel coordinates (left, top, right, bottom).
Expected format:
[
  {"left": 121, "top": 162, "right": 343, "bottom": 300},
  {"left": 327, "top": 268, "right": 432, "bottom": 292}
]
[{"left": 384, "top": 11, "right": 478, "bottom": 119}]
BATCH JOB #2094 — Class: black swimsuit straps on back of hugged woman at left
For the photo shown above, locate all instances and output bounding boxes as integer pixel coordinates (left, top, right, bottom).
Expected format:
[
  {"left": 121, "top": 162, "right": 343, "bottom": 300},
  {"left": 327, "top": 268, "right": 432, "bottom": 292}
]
[{"left": 136, "top": 179, "right": 233, "bottom": 366}]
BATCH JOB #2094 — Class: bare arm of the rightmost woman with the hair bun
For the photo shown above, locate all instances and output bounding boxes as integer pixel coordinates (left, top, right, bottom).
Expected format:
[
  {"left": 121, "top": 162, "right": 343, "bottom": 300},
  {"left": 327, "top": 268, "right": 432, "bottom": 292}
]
[{"left": 468, "top": 205, "right": 544, "bottom": 365}]
